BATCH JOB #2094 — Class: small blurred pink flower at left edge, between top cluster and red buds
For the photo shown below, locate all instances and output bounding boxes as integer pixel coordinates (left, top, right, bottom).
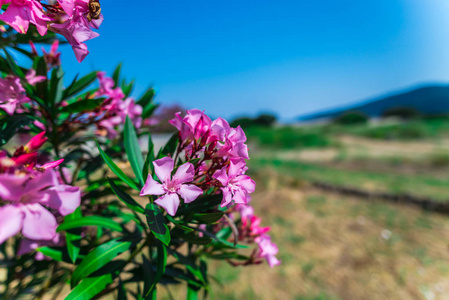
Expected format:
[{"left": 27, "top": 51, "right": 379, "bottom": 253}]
[{"left": 0, "top": 76, "right": 30, "bottom": 115}]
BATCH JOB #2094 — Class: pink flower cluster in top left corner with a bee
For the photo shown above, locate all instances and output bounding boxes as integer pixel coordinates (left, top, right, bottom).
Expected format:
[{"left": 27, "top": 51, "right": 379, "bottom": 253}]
[{"left": 0, "top": 0, "right": 103, "bottom": 62}]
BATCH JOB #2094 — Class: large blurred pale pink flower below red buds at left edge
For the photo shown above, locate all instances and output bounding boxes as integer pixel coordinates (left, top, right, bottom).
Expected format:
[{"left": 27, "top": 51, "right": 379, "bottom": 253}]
[{"left": 0, "top": 170, "right": 81, "bottom": 244}]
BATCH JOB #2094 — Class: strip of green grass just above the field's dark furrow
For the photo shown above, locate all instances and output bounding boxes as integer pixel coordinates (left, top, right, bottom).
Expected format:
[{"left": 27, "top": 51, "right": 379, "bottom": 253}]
[{"left": 249, "top": 158, "right": 449, "bottom": 201}]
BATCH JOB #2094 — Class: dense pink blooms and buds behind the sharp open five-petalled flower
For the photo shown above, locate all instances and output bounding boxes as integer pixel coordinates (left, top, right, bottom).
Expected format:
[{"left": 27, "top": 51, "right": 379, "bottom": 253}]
[{"left": 170, "top": 109, "right": 256, "bottom": 207}]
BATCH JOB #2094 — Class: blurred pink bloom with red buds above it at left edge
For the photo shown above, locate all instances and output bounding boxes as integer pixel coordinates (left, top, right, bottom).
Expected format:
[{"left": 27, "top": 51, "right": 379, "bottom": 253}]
[{"left": 0, "top": 132, "right": 81, "bottom": 244}]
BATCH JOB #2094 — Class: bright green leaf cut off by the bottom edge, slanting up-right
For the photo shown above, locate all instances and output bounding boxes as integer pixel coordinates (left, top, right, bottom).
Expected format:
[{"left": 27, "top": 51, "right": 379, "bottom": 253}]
[{"left": 65, "top": 274, "right": 113, "bottom": 300}]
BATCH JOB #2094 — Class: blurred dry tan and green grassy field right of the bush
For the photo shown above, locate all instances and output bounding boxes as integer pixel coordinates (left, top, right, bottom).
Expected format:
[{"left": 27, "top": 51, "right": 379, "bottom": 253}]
[{"left": 183, "top": 120, "right": 449, "bottom": 300}]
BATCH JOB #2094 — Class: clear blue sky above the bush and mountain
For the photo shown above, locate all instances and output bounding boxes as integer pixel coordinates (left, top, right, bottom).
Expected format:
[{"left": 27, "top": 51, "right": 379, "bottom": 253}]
[{"left": 57, "top": 0, "right": 449, "bottom": 120}]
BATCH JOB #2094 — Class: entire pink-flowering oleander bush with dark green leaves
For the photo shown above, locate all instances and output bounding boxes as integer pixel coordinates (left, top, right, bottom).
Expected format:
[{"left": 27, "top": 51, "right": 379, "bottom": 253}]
[{"left": 0, "top": 0, "right": 280, "bottom": 299}]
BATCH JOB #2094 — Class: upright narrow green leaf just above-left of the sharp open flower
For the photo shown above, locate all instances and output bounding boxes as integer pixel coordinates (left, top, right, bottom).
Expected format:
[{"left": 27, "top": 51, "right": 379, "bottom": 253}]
[{"left": 123, "top": 117, "right": 145, "bottom": 186}]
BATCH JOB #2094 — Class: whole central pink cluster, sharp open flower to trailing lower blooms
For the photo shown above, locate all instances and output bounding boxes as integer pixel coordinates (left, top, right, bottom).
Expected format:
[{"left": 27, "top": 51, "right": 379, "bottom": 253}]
[{"left": 140, "top": 109, "right": 280, "bottom": 267}]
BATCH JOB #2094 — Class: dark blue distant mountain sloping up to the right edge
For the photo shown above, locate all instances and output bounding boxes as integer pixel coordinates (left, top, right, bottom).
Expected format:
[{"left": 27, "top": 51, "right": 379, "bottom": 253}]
[{"left": 298, "top": 85, "right": 449, "bottom": 121}]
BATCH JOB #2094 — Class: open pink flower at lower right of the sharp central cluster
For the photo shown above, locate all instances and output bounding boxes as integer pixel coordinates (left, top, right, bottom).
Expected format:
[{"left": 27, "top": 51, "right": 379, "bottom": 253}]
[{"left": 213, "top": 159, "right": 256, "bottom": 207}]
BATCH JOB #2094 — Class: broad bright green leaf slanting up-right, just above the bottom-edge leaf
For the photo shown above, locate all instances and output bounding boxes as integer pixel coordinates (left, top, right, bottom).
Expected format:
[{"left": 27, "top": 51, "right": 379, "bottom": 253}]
[{"left": 71, "top": 239, "right": 132, "bottom": 287}]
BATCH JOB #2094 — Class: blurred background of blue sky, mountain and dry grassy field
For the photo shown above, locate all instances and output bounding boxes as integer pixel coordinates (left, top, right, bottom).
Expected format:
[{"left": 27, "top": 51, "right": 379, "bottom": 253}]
[{"left": 70, "top": 0, "right": 449, "bottom": 300}]
